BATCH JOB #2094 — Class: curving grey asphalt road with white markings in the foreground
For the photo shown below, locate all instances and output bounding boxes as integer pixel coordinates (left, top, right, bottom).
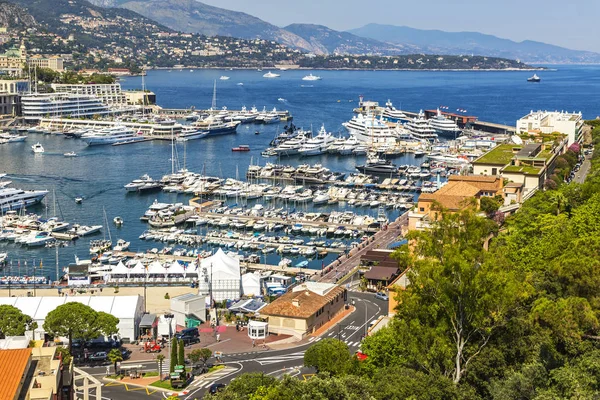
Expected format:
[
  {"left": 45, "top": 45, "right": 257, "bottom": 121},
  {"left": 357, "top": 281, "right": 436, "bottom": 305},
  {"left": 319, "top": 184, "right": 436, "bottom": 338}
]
[{"left": 77, "top": 292, "right": 387, "bottom": 400}]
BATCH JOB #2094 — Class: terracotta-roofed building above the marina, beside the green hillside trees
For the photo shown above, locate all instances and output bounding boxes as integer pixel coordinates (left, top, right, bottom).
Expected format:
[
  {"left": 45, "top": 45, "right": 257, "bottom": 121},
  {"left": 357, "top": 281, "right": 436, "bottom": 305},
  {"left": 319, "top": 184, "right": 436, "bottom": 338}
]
[{"left": 408, "top": 175, "right": 504, "bottom": 231}]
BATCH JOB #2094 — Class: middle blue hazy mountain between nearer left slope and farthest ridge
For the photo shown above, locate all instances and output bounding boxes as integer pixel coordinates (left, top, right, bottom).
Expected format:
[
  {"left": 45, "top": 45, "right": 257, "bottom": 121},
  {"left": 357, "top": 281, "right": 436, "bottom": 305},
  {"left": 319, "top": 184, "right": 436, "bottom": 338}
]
[{"left": 283, "top": 24, "right": 412, "bottom": 55}]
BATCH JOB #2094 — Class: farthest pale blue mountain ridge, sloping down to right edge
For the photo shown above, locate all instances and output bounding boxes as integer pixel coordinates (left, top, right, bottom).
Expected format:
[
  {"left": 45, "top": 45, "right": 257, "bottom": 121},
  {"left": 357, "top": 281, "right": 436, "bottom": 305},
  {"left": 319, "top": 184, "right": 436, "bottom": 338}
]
[{"left": 348, "top": 24, "right": 600, "bottom": 63}]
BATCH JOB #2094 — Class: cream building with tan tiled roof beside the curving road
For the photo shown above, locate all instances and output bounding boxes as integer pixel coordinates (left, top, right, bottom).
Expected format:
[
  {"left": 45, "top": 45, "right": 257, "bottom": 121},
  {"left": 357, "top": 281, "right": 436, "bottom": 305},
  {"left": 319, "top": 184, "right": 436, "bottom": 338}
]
[{"left": 260, "top": 282, "right": 348, "bottom": 339}]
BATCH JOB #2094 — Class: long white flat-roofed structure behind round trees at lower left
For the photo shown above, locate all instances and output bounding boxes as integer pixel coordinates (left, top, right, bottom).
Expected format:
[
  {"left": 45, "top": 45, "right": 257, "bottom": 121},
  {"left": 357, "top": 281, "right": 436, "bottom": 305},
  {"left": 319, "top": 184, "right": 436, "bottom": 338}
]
[{"left": 0, "top": 296, "right": 144, "bottom": 340}]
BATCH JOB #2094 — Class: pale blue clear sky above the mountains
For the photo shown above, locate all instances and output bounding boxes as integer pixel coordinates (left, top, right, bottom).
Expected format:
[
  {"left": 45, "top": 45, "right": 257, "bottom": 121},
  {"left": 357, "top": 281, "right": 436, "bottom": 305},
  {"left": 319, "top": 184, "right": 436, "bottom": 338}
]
[{"left": 200, "top": 0, "right": 600, "bottom": 52}]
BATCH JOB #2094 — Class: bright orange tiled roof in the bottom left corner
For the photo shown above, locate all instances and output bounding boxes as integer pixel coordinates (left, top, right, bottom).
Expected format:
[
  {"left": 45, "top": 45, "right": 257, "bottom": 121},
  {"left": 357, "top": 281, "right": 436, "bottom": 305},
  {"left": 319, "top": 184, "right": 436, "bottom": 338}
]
[{"left": 0, "top": 349, "right": 31, "bottom": 400}]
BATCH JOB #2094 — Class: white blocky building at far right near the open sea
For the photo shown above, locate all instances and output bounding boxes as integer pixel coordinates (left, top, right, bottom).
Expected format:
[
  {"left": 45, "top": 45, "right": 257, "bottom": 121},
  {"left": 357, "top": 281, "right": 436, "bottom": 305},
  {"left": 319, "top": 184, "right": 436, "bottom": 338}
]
[{"left": 516, "top": 111, "right": 583, "bottom": 146}]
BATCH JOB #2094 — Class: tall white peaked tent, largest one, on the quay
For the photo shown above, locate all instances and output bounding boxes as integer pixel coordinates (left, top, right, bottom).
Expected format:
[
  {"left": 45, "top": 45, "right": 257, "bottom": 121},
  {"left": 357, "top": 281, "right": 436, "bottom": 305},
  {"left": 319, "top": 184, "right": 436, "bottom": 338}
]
[{"left": 198, "top": 249, "right": 241, "bottom": 301}]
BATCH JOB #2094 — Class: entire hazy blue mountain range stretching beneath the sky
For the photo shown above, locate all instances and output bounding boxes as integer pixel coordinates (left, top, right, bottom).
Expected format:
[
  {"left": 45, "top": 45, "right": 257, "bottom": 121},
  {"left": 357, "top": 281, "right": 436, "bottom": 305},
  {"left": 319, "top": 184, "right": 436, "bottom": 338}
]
[{"left": 85, "top": 0, "right": 600, "bottom": 63}]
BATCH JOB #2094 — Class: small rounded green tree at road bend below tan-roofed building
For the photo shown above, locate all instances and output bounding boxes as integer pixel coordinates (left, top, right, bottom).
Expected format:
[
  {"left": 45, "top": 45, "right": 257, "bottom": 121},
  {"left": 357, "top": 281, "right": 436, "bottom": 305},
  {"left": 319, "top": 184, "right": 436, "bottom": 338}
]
[{"left": 304, "top": 338, "right": 351, "bottom": 375}]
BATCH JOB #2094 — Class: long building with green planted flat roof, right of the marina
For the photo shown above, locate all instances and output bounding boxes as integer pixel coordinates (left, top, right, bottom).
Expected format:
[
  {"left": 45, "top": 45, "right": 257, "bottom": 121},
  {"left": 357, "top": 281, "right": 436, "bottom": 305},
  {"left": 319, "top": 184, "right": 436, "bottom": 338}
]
[{"left": 472, "top": 139, "right": 568, "bottom": 201}]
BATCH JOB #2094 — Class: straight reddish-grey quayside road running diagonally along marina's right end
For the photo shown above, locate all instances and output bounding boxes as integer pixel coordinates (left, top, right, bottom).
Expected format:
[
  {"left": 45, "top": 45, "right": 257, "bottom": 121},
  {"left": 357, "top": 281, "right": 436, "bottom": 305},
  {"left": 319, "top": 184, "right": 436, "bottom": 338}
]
[{"left": 318, "top": 212, "right": 408, "bottom": 283}]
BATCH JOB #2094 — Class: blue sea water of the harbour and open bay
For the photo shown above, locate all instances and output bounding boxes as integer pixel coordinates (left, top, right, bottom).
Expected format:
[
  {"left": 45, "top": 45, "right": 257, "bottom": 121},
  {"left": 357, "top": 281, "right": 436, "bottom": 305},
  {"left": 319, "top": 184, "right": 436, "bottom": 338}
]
[{"left": 0, "top": 66, "right": 600, "bottom": 279}]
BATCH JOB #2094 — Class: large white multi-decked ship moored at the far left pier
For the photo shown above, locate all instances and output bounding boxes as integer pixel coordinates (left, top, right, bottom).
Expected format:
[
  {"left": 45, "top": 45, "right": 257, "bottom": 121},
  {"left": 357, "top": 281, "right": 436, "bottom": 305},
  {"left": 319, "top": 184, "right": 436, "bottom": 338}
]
[{"left": 21, "top": 93, "right": 112, "bottom": 122}]
